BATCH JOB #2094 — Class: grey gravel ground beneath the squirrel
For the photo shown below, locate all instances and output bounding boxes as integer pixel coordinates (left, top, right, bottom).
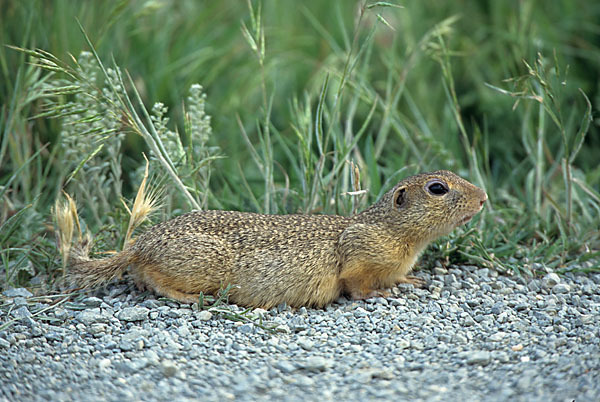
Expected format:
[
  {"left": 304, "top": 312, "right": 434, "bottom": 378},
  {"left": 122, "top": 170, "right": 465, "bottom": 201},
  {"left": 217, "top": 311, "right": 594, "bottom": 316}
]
[{"left": 0, "top": 266, "right": 600, "bottom": 402}]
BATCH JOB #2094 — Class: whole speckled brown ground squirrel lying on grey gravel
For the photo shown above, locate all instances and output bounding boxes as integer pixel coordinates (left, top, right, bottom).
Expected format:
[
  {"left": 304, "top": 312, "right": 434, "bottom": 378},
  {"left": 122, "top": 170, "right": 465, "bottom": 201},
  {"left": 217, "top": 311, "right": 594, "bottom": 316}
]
[{"left": 69, "top": 170, "right": 487, "bottom": 309}]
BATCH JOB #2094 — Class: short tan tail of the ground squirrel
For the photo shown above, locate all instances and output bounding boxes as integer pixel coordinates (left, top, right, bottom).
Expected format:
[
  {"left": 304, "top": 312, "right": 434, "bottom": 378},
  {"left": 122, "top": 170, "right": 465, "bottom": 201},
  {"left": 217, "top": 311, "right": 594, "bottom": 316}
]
[{"left": 67, "top": 236, "right": 131, "bottom": 288}]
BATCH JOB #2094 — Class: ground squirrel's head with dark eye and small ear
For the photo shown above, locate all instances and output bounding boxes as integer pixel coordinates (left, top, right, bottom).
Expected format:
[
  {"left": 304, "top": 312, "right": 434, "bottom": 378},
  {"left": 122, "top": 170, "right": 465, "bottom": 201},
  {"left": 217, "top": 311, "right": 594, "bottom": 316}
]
[{"left": 370, "top": 170, "right": 487, "bottom": 240}]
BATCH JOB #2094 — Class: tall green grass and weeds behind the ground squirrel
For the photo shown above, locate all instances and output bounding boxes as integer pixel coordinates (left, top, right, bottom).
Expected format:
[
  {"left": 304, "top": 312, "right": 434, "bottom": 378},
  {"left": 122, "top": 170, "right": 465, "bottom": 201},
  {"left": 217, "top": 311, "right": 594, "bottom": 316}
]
[{"left": 0, "top": 0, "right": 600, "bottom": 287}]
